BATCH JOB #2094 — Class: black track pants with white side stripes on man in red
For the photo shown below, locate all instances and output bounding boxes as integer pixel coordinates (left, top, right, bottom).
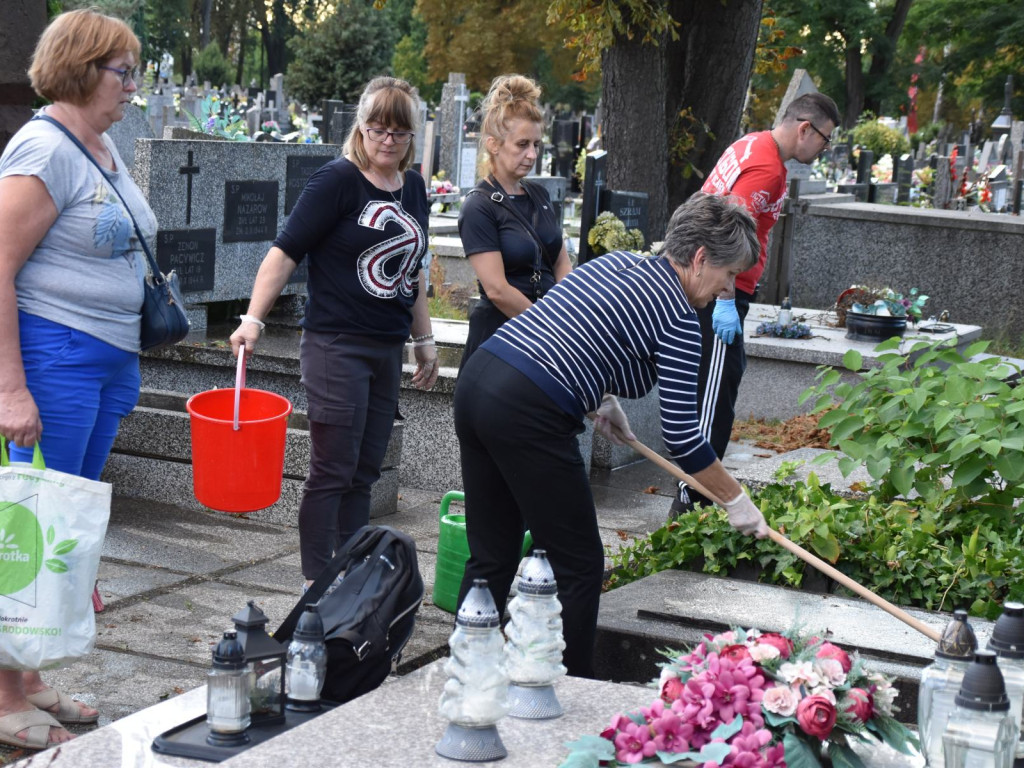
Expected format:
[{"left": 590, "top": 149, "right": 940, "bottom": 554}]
[{"left": 689, "top": 289, "right": 754, "bottom": 505}]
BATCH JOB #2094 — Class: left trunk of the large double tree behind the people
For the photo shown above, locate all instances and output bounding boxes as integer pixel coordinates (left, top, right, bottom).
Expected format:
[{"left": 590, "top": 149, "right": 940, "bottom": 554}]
[{"left": 601, "top": 35, "right": 669, "bottom": 241}]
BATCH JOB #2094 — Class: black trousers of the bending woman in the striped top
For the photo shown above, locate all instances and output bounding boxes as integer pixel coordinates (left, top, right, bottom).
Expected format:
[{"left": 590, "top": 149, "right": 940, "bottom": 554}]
[{"left": 455, "top": 349, "right": 604, "bottom": 677}]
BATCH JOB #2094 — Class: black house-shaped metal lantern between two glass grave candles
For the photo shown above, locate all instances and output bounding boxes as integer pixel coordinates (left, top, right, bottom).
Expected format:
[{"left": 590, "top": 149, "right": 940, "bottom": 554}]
[{"left": 231, "top": 600, "right": 286, "bottom": 728}]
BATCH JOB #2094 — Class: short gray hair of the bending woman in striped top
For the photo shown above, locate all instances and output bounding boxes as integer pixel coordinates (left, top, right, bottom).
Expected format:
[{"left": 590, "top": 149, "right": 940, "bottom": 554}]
[{"left": 663, "top": 193, "right": 761, "bottom": 271}]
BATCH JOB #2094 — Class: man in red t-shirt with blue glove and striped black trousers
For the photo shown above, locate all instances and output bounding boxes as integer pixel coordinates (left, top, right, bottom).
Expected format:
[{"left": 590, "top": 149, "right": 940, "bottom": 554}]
[{"left": 672, "top": 93, "right": 840, "bottom": 515}]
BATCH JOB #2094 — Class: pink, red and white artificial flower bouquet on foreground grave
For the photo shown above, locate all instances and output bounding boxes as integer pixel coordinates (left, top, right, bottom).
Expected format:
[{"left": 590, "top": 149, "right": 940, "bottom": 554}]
[{"left": 560, "top": 628, "right": 920, "bottom": 768}]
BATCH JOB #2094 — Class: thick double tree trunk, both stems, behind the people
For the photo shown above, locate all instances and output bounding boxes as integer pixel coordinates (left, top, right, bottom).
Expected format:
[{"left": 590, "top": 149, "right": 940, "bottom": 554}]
[{"left": 601, "top": 0, "right": 762, "bottom": 240}]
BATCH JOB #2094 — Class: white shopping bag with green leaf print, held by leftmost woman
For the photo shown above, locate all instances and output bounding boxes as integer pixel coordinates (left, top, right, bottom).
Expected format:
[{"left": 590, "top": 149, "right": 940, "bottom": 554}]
[{"left": 0, "top": 438, "right": 111, "bottom": 670}]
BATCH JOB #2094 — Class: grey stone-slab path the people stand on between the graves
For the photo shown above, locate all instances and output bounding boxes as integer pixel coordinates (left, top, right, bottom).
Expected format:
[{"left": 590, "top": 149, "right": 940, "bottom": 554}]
[{"left": 0, "top": 445, "right": 763, "bottom": 765}]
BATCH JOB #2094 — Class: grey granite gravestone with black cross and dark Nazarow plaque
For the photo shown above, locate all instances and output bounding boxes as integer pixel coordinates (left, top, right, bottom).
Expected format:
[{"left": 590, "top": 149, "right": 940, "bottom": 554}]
[{"left": 132, "top": 139, "right": 338, "bottom": 330}]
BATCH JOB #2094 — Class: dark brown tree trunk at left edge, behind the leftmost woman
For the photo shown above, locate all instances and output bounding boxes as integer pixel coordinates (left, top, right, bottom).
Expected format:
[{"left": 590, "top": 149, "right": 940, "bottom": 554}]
[{"left": 0, "top": 0, "right": 46, "bottom": 152}]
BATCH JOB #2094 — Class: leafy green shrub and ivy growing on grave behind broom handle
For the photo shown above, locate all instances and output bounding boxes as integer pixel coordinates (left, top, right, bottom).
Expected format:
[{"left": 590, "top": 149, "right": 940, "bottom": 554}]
[{"left": 608, "top": 340, "right": 1024, "bottom": 618}]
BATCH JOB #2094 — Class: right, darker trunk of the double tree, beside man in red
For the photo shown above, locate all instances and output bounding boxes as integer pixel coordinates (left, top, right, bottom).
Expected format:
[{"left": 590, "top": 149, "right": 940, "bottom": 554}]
[{"left": 666, "top": 0, "right": 762, "bottom": 208}]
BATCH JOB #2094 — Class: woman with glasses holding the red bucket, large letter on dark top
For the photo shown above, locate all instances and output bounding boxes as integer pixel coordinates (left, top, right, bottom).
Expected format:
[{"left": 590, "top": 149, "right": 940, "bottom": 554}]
[{"left": 230, "top": 77, "right": 438, "bottom": 584}]
